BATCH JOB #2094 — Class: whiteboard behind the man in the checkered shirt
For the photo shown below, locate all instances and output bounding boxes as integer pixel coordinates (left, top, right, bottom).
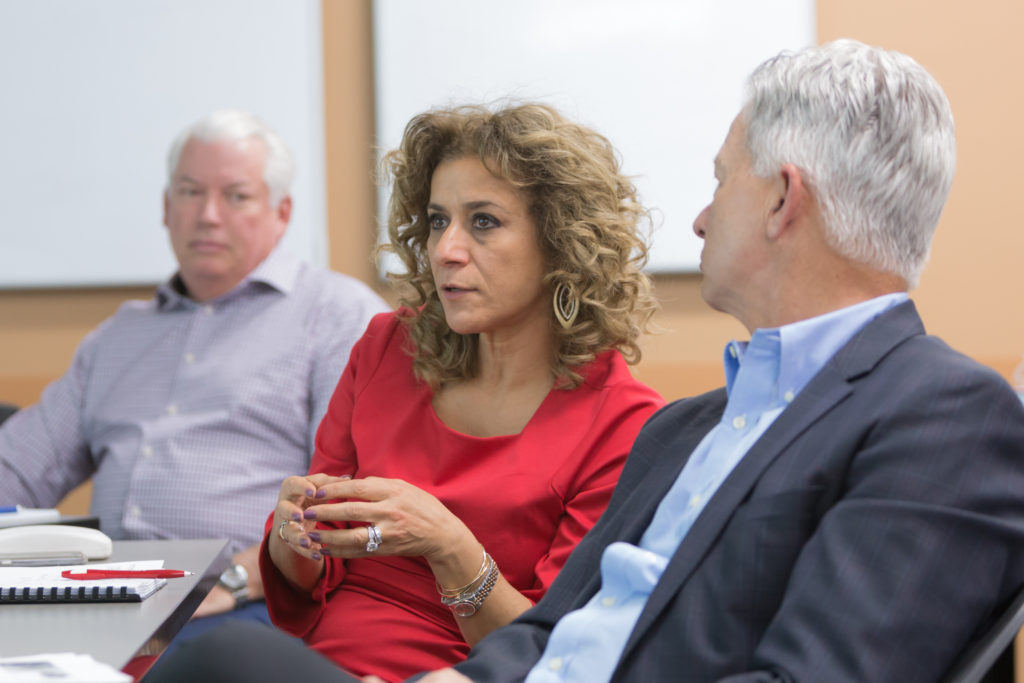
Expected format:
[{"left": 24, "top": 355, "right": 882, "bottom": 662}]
[{"left": 0, "top": 0, "right": 327, "bottom": 288}]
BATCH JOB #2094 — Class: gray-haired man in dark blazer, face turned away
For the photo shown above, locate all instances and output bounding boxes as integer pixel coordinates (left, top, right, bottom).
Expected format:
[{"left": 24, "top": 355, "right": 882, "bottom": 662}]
[{"left": 142, "top": 41, "right": 1024, "bottom": 683}]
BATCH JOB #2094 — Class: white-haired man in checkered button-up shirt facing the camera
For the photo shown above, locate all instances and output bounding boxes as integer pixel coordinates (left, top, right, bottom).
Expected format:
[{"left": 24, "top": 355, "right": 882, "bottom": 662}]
[{"left": 0, "top": 111, "right": 387, "bottom": 638}]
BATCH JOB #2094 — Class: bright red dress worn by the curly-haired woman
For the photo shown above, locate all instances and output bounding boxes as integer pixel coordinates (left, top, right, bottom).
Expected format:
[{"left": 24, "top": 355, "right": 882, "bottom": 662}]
[{"left": 260, "top": 312, "right": 665, "bottom": 680}]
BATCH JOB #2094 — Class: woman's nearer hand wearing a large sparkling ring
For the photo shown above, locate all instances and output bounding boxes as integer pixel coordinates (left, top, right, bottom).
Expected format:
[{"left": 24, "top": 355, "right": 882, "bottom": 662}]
[{"left": 304, "top": 477, "right": 479, "bottom": 564}]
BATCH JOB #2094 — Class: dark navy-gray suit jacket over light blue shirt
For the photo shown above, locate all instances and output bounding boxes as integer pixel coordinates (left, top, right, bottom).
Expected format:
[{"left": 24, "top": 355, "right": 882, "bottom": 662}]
[{"left": 457, "top": 302, "right": 1024, "bottom": 683}]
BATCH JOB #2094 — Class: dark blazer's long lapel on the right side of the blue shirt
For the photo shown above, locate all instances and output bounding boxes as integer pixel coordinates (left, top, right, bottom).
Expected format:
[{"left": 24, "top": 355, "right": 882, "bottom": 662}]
[{"left": 625, "top": 301, "right": 924, "bottom": 652}]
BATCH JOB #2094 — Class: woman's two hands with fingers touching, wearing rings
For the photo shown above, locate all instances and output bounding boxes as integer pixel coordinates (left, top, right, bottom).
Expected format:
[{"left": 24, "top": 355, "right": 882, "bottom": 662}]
[{"left": 271, "top": 474, "right": 472, "bottom": 560}]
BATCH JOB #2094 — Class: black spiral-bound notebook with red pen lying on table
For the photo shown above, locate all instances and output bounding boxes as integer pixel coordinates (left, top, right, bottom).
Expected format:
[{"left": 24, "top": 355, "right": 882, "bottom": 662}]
[{"left": 0, "top": 560, "right": 167, "bottom": 605}]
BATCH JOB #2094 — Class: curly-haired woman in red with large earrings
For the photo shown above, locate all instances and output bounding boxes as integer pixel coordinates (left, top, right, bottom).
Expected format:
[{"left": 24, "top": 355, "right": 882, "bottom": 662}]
[{"left": 144, "top": 104, "right": 664, "bottom": 680}]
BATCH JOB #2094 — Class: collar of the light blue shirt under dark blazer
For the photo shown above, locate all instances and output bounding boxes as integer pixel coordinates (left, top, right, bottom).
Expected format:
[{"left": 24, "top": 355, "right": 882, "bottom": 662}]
[{"left": 724, "top": 292, "right": 909, "bottom": 402}]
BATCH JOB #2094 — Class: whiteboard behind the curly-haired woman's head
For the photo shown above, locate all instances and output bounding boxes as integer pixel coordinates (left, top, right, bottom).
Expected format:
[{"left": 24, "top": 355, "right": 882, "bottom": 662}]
[{"left": 374, "top": 0, "right": 816, "bottom": 271}]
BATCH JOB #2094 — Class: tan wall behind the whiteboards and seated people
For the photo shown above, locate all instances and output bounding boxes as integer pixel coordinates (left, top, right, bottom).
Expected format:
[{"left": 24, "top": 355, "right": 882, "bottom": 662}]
[{"left": 0, "top": 0, "right": 1024, "bottom": 411}]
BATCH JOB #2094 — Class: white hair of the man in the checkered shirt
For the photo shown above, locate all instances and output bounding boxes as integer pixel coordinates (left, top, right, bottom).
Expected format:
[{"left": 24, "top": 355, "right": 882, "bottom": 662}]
[{"left": 167, "top": 110, "right": 295, "bottom": 206}]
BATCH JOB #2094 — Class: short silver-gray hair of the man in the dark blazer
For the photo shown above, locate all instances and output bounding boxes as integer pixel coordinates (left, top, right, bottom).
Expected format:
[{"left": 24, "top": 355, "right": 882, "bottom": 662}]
[{"left": 743, "top": 40, "right": 956, "bottom": 288}]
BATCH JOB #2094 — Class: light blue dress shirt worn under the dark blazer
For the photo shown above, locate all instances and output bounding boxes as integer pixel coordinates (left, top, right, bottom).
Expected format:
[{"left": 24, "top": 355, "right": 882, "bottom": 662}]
[{"left": 526, "top": 293, "right": 907, "bottom": 683}]
